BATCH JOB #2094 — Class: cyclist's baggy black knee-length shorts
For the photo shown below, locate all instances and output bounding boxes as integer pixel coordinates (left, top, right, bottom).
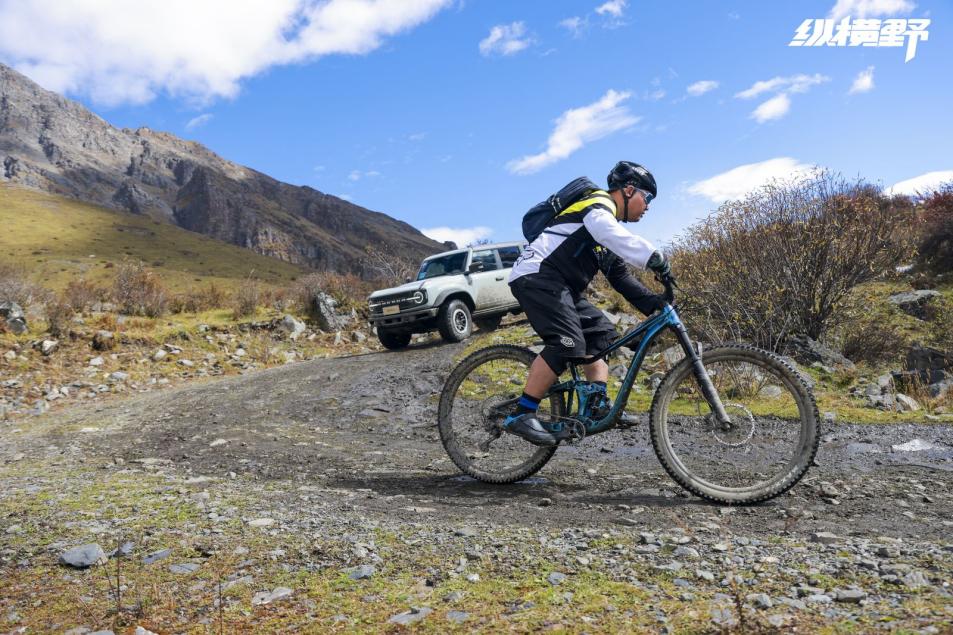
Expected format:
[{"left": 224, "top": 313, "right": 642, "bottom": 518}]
[{"left": 510, "top": 275, "right": 616, "bottom": 375}]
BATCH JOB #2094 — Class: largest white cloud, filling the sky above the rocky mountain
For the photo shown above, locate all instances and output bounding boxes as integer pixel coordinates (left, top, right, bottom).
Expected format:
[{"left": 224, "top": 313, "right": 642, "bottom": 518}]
[{"left": 0, "top": 0, "right": 453, "bottom": 105}]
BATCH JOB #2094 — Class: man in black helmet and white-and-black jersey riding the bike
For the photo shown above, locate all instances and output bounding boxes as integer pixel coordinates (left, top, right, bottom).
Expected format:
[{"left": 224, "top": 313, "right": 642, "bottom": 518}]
[{"left": 503, "top": 161, "right": 671, "bottom": 446}]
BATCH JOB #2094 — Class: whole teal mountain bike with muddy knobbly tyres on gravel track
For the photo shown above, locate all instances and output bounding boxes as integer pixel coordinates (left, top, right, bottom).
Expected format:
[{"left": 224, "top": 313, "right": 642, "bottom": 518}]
[{"left": 438, "top": 278, "right": 820, "bottom": 505}]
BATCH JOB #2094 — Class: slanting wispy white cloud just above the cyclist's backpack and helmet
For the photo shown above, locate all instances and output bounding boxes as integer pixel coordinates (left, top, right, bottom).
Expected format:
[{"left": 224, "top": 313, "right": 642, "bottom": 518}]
[{"left": 506, "top": 90, "right": 641, "bottom": 174}]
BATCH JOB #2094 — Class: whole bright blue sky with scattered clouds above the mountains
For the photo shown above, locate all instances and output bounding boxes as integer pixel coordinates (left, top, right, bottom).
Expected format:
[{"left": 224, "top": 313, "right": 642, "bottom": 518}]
[{"left": 0, "top": 0, "right": 953, "bottom": 248}]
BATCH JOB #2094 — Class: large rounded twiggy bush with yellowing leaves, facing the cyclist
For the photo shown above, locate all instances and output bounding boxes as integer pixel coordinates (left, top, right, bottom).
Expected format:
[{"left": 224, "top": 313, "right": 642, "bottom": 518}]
[{"left": 670, "top": 172, "right": 914, "bottom": 350}]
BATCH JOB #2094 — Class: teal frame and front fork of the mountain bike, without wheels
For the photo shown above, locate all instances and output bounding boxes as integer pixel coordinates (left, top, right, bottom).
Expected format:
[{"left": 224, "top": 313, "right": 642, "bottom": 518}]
[{"left": 549, "top": 304, "right": 731, "bottom": 435}]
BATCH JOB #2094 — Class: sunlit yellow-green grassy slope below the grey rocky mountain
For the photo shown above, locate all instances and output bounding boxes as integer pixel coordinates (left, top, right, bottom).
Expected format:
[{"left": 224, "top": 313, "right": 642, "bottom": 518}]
[{"left": 0, "top": 185, "right": 308, "bottom": 291}]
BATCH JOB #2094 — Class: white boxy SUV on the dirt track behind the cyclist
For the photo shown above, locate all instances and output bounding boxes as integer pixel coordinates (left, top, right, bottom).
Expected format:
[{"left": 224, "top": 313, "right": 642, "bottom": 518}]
[{"left": 368, "top": 242, "right": 524, "bottom": 349}]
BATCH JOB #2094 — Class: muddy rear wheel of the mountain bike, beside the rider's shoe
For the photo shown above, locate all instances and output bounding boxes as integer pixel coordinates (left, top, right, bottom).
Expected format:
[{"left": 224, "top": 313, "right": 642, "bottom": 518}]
[{"left": 437, "top": 345, "right": 565, "bottom": 483}]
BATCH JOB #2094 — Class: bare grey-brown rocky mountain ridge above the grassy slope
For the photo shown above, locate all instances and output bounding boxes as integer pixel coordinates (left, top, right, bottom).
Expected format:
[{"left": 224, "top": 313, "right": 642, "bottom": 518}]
[{"left": 0, "top": 64, "right": 447, "bottom": 278}]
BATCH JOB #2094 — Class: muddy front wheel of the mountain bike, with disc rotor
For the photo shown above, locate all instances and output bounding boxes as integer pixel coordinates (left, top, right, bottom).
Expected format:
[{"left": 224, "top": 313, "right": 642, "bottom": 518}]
[{"left": 650, "top": 346, "right": 820, "bottom": 505}]
